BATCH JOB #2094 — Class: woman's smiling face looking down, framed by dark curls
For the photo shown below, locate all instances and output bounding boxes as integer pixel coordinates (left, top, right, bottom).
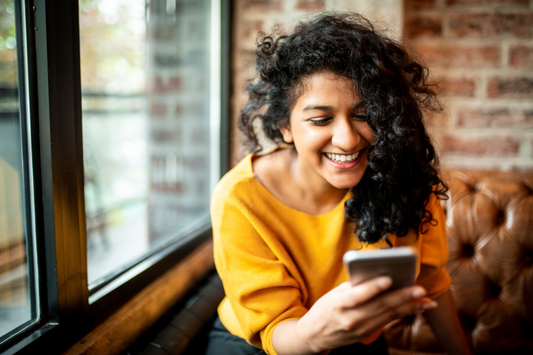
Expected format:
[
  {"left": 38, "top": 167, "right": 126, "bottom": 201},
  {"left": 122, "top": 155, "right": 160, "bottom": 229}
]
[{"left": 280, "top": 73, "right": 374, "bottom": 189}]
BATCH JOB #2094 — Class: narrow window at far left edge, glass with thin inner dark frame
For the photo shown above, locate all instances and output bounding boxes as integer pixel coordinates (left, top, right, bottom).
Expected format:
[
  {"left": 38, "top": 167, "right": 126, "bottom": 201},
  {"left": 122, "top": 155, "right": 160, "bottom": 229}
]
[{"left": 0, "top": 0, "right": 38, "bottom": 341}]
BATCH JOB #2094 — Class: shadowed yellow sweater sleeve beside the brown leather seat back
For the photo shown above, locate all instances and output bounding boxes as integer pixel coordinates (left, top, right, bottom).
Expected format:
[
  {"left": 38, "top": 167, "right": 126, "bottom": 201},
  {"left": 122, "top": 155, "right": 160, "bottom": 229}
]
[{"left": 416, "top": 194, "right": 451, "bottom": 299}]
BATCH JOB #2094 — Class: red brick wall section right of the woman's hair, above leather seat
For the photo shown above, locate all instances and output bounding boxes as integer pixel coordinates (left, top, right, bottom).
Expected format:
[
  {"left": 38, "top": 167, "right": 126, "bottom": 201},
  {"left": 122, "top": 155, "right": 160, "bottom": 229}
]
[{"left": 404, "top": 0, "right": 533, "bottom": 171}]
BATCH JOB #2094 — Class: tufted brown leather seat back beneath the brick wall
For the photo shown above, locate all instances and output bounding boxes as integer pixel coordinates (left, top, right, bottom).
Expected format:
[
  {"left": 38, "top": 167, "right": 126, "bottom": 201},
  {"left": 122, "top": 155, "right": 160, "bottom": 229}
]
[{"left": 385, "top": 171, "right": 533, "bottom": 355}]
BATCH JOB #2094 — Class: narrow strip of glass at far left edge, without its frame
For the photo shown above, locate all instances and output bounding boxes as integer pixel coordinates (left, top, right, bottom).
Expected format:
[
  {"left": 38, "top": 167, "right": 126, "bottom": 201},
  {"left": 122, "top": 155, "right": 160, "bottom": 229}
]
[{"left": 0, "top": 0, "right": 32, "bottom": 338}]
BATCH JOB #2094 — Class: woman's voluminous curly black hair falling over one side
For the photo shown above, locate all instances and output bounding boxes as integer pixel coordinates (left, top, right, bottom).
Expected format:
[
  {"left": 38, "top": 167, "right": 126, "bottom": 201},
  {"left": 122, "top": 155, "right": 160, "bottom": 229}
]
[{"left": 239, "top": 13, "right": 448, "bottom": 244}]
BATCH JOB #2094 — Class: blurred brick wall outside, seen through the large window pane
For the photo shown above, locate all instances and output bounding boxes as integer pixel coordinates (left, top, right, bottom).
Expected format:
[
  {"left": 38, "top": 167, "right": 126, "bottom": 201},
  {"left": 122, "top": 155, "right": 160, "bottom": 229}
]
[{"left": 147, "top": 0, "right": 210, "bottom": 243}]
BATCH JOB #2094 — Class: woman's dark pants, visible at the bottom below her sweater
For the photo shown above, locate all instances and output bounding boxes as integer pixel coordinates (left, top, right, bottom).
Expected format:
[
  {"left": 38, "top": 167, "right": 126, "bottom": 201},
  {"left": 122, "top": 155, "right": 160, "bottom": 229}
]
[{"left": 206, "top": 317, "right": 389, "bottom": 355}]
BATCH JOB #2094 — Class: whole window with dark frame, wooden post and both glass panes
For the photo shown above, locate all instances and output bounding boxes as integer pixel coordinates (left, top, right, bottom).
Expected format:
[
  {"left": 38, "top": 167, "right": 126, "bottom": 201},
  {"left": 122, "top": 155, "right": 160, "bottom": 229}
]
[{"left": 0, "top": 0, "right": 229, "bottom": 354}]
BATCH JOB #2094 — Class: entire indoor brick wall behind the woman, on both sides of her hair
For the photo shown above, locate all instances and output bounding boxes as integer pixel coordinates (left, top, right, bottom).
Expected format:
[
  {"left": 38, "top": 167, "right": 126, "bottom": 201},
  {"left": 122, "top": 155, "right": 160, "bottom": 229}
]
[{"left": 232, "top": 0, "right": 533, "bottom": 170}]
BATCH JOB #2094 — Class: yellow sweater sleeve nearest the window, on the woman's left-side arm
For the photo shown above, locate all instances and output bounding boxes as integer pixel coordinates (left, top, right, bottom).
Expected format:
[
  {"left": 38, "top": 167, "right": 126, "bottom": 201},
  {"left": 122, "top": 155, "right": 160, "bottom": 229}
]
[{"left": 211, "top": 185, "right": 307, "bottom": 354}]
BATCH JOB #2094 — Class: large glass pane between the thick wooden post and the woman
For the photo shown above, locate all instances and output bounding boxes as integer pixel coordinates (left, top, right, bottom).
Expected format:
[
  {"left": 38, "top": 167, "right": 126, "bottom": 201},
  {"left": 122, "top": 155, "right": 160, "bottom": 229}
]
[{"left": 80, "top": 0, "right": 211, "bottom": 287}]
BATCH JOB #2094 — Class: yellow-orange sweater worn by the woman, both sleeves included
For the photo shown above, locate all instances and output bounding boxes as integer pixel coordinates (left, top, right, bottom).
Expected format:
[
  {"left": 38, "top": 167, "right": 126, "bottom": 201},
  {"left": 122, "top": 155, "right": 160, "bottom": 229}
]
[{"left": 211, "top": 154, "right": 450, "bottom": 354}]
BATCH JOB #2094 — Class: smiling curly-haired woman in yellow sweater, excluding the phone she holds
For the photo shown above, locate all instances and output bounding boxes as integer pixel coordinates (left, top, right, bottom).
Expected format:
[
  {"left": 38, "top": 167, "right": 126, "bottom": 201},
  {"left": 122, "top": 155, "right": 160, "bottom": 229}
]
[{"left": 208, "top": 14, "right": 470, "bottom": 355}]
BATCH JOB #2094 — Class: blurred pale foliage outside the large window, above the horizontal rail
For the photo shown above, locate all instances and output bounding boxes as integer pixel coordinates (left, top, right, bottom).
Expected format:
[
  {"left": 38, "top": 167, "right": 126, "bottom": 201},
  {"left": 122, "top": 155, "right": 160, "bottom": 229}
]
[{"left": 79, "top": 0, "right": 146, "bottom": 94}]
